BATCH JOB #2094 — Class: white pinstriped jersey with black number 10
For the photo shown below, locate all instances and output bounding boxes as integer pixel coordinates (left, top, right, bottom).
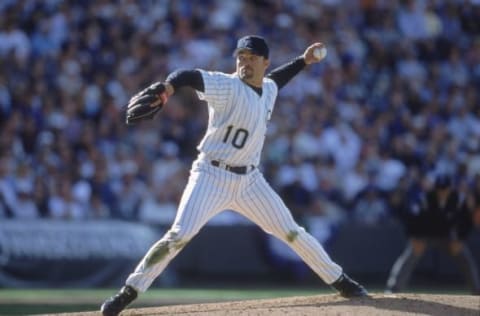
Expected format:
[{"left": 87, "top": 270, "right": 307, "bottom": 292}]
[{"left": 197, "top": 70, "right": 278, "bottom": 166}]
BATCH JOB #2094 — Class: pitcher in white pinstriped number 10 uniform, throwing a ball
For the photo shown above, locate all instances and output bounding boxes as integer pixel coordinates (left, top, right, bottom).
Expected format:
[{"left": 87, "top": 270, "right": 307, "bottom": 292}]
[{"left": 101, "top": 35, "right": 368, "bottom": 315}]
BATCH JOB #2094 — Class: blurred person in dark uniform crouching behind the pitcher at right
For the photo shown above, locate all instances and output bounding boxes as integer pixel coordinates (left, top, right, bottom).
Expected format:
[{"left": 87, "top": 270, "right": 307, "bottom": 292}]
[{"left": 386, "top": 175, "right": 480, "bottom": 295}]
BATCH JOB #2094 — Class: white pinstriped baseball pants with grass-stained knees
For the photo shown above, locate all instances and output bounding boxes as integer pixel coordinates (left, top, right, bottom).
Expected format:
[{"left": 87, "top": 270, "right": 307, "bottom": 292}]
[{"left": 126, "top": 159, "right": 342, "bottom": 292}]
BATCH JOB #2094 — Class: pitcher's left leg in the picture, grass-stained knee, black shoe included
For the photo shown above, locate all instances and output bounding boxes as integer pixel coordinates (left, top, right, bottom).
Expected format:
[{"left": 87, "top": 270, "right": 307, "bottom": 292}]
[{"left": 100, "top": 163, "right": 232, "bottom": 316}]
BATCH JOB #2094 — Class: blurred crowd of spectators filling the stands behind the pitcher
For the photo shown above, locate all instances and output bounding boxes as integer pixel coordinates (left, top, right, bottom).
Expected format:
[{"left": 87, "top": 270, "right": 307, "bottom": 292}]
[{"left": 0, "top": 0, "right": 480, "bottom": 227}]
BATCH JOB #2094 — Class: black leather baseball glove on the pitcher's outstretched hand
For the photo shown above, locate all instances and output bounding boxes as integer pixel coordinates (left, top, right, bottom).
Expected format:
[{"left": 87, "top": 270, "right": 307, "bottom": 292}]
[{"left": 126, "top": 82, "right": 168, "bottom": 124}]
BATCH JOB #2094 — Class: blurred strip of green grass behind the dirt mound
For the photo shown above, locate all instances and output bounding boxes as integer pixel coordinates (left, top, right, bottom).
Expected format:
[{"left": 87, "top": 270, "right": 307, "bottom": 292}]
[{"left": 0, "top": 287, "right": 468, "bottom": 316}]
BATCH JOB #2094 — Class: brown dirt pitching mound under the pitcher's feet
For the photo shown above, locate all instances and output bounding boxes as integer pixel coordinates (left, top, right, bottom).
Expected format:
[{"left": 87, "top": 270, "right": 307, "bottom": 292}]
[{"left": 65, "top": 294, "right": 480, "bottom": 316}]
